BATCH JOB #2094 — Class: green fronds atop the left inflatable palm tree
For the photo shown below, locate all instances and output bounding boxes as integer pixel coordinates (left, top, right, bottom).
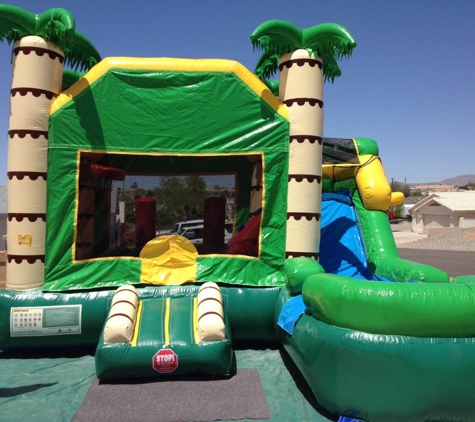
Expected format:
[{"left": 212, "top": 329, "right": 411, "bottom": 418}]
[{"left": 0, "top": 4, "right": 101, "bottom": 69}]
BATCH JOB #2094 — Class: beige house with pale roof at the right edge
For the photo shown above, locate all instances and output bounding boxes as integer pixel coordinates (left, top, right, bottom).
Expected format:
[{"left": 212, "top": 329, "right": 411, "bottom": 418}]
[{"left": 411, "top": 191, "right": 475, "bottom": 235}]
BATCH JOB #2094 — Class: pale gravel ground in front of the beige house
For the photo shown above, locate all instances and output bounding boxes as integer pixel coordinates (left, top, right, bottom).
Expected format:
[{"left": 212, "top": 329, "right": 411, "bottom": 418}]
[{"left": 391, "top": 222, "right": 475, "bottom": 251}]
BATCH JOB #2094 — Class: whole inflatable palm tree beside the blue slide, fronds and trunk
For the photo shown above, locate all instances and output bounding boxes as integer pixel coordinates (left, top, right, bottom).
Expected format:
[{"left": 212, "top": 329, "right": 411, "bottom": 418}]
[{"left": 251, "top": 20, "right": 356, "bottom": 259}]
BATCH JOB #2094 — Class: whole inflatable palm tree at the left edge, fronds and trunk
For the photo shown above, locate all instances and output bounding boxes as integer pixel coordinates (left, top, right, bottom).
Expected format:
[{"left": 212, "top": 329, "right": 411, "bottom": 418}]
[{"left": 0, "top": 5, "right": 100, "bottom": 290}]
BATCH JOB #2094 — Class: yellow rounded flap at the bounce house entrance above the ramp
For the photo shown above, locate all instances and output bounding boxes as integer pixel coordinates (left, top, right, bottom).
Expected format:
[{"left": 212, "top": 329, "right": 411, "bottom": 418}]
[{"left": 140, "top": 234, "right": 198, "bottom": 286}]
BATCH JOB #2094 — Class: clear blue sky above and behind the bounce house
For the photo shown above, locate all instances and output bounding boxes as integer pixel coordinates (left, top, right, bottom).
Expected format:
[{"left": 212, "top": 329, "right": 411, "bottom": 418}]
[{"left": 0, "top": 0, "right": 475, "bottom": 185}]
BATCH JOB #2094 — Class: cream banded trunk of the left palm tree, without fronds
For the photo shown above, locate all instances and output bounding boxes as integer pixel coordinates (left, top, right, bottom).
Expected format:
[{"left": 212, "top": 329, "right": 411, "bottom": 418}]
[{"left": 7, "top": 36, "right": 64, "bottom": 290}]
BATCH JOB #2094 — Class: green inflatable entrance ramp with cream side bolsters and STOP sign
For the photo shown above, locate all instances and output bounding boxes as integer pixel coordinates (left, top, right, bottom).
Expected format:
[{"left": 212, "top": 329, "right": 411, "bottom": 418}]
[{"left": 96, "top": 283, "right": 233, "bottom": 379}]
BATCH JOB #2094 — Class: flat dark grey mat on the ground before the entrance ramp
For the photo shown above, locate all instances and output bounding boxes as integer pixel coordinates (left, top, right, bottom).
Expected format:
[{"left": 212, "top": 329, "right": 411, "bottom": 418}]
[{"left": 73, "top": 369, "right": 271, "bottom": 422}]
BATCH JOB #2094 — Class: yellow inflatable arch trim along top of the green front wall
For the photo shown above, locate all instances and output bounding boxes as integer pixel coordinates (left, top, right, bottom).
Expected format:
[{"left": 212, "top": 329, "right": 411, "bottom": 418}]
[{"left": 50, "top": 57, "right": 289, "bottom": 120}]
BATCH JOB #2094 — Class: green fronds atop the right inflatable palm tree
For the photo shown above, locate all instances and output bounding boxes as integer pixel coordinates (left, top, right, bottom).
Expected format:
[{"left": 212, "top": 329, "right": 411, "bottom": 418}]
[{"left": 251, "top": 20, "right": 356, "bottom": 82}]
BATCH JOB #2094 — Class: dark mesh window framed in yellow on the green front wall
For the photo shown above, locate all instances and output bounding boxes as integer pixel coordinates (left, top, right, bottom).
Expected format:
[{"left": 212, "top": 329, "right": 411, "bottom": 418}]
[{"left": 75, "top": 152, "right": 262, "bottom": 260}]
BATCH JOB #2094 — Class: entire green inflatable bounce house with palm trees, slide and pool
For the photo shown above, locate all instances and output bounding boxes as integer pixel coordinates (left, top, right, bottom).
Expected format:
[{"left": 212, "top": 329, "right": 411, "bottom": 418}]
[{"left": 0, "top": 6, "right": 475, "bottom": 421}]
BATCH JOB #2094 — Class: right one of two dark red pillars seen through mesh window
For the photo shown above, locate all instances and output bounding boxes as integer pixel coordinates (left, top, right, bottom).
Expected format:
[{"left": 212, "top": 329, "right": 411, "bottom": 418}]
[{"left": 203, "top": 197, "right": 226, "bottom": 254}]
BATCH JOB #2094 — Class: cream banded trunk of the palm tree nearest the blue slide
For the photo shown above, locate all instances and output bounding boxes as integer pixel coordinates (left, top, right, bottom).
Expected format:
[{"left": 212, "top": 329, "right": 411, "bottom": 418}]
[{"left": 279, "top": 49, "right": 323, "bottom": 260}]
